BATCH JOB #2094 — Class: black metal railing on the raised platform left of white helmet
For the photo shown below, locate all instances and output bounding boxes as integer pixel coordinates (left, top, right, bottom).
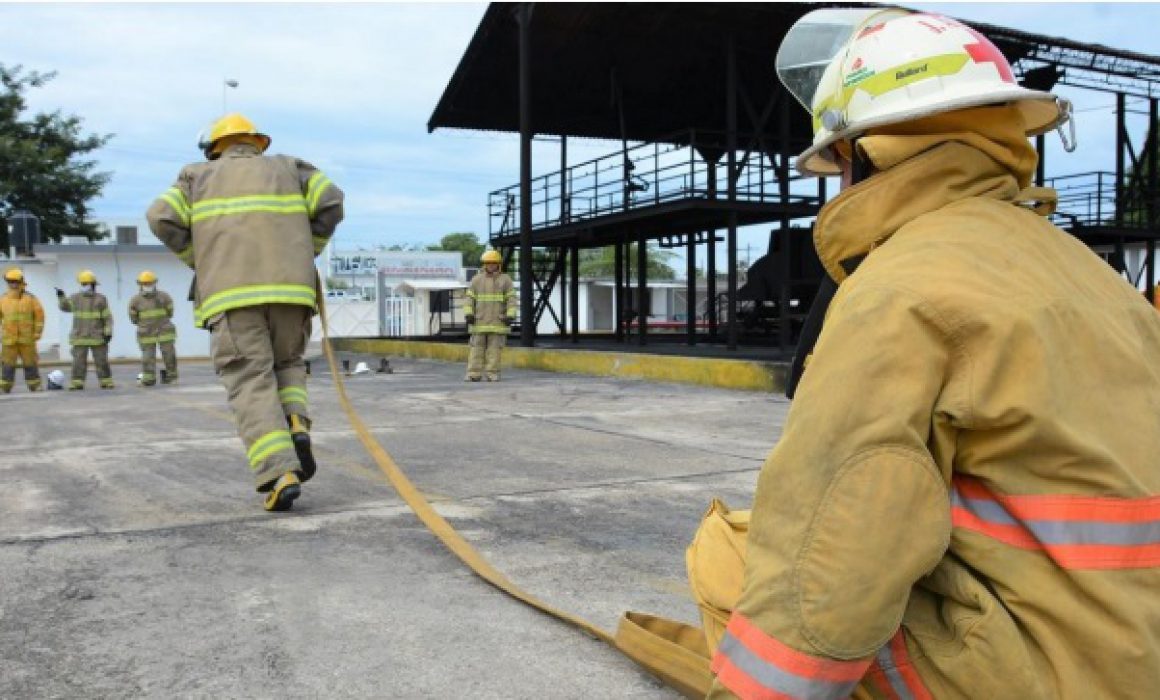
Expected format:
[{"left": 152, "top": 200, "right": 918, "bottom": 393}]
[{"left": 487, "top": 131, "right": 821, "bottom": 238}]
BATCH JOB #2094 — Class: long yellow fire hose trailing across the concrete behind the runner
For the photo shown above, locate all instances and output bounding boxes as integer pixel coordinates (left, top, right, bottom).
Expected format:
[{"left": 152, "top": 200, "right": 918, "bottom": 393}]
[{"left": 318, "top": 297, "right": 712, "bottom": 698}]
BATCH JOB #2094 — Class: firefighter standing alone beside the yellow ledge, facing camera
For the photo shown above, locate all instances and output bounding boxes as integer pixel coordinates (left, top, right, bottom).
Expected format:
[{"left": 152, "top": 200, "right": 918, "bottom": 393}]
[{"left": 463, "top": 251, "right": 516, "bottom": 382}]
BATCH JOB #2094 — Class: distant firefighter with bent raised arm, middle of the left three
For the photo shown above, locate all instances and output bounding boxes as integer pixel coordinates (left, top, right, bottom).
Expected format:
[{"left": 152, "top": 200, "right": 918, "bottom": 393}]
[{"left": 57, "top": 269, "right": 113, "bottom": 391}]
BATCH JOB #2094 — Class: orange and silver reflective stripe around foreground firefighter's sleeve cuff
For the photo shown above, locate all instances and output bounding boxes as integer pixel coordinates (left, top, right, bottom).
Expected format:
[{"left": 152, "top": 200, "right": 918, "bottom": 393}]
[{"left": 711, "top": 612, "right": 871, "bottom": 698}]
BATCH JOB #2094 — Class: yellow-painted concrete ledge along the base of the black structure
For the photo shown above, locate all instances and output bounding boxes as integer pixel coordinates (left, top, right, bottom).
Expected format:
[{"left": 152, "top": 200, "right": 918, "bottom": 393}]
[{"left": 331, "top": 338, "right": 788, "bottom": 392}]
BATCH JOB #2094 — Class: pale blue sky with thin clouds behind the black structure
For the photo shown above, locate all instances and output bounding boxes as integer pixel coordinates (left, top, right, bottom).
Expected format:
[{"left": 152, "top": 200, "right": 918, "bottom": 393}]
[{"left": 0, "top": 2, "right": 1160, "bottom": 268}]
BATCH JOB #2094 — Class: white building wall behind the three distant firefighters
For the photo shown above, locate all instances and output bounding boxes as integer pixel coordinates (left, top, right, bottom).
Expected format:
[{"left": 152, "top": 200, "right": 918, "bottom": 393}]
[{"left": 14, "top": 245, "right": 210, "bottom": 360}]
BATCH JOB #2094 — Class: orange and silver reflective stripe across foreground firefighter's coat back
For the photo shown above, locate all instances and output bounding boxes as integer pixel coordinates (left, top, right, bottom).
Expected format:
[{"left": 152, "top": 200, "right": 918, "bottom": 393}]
[{"left": 951, "top": 476, "right": 1160, "bottom": 569}]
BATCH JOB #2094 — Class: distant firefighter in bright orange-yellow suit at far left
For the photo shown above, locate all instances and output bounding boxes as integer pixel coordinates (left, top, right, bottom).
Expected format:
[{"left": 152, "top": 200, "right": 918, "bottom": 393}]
[{"left": 0, "top": 267, "right": 44, "bottom": 394}]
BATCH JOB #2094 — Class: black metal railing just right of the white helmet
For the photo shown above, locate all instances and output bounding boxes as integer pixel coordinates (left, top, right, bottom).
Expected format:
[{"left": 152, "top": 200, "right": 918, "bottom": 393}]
[{"left": 1044, "top": 172, "right": 1160, "bottom": 229}]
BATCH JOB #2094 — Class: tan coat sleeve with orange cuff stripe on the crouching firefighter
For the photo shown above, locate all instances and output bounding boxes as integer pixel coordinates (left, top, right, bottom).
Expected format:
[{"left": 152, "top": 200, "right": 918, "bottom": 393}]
[{"left": 710, "top": 277, "right": 966, "bottom": 698}]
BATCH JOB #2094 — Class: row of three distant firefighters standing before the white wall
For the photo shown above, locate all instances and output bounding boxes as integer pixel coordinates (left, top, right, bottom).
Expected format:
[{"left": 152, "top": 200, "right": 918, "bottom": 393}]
[{"left": 0, "top": 267, "right": 177, "bottom": 394}]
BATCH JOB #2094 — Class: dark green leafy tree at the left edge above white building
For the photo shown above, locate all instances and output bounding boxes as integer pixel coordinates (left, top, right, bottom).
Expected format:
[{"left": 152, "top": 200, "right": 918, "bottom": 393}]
[{"left": 0, "top": 65, "right": 113, "bottom": 243}]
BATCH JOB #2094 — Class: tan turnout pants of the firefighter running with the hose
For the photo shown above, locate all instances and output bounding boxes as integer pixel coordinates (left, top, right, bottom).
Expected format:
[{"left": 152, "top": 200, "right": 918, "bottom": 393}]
[{"left": 211, "top": 304, "right": 312, "bottom": 491}]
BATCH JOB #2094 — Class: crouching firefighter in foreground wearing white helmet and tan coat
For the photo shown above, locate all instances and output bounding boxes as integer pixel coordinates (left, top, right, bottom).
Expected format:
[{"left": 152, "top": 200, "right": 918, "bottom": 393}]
[{"left": 711, "top": 9, "right": 1160, "bottom": 700}]
